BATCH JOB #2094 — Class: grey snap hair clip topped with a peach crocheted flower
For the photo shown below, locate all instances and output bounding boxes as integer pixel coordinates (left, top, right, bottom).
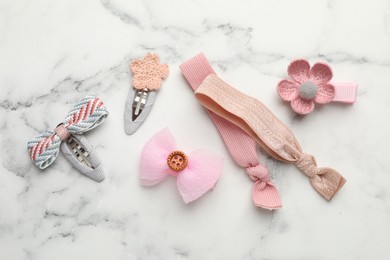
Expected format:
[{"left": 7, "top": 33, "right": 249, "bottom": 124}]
[{"left": 125, "top": 53, "right": 169, "bottom": 135}]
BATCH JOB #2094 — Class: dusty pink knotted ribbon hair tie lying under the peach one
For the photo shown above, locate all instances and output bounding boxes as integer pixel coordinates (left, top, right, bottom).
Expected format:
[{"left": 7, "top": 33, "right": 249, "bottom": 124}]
[{"left": 180, "top": 54, "right": 282, "bottom": 210}]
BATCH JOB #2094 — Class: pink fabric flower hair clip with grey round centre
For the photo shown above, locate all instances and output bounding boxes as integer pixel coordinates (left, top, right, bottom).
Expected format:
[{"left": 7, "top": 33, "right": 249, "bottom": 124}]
[{"left": 277, "top": 59, "right": 357, "bottom": 115}]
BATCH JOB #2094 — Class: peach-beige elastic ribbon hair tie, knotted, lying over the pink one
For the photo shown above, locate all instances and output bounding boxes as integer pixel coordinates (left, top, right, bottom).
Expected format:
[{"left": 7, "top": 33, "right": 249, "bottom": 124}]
[{"left": 182, "top": 54, "right": 345, "bottom": 203}]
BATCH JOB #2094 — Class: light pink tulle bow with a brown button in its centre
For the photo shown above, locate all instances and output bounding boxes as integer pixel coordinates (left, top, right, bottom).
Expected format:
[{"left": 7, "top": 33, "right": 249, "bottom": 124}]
[{"left": 139, "top": 128, "right": 223, "bottom": 203}]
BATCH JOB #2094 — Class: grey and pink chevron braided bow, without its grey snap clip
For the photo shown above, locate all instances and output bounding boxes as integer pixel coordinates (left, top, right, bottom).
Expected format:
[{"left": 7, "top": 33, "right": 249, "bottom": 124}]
[{"left": 27, "top": 96, "right": 108, "bottom": 169}]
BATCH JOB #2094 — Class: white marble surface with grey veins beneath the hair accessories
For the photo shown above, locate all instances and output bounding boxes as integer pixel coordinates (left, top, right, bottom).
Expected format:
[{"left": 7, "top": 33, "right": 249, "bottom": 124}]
[{"left": 0, "top": 0, "right": 390, "bottom": 260}]
